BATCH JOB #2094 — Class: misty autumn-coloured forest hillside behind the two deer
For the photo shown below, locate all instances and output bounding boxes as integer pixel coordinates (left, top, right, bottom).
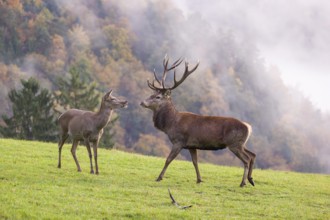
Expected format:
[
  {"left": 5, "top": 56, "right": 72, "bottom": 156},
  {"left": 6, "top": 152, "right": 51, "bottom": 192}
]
[{"left": 0, "top": 0, "right": 330, "bottom": 173}]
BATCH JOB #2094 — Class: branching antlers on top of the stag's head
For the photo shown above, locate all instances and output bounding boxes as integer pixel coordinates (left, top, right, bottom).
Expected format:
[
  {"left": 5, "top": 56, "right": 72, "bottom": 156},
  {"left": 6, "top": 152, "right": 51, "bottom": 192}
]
[{"left": 147, "top": 56, "right": 199, "bottom": 91}]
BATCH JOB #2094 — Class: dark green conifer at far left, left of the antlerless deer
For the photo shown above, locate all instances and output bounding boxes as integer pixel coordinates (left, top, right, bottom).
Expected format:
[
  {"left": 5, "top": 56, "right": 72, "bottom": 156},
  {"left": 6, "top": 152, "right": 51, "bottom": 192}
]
[{"left": 0, "top": 77, "right": 56, "bottom": 141}]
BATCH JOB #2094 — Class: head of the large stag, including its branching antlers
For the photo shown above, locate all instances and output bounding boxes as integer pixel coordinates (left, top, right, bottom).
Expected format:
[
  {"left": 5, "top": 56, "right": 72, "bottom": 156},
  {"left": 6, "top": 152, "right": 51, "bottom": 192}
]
[{"left": 141, "top": 56, "right": 199, "bottom": 110}]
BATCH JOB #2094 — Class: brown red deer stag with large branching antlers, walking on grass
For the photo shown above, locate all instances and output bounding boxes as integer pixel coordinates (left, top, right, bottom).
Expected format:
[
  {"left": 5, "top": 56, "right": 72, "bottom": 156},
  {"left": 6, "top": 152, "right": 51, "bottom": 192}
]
[{"left": 141, "top": 57, "right": 256, "bottom": 187}]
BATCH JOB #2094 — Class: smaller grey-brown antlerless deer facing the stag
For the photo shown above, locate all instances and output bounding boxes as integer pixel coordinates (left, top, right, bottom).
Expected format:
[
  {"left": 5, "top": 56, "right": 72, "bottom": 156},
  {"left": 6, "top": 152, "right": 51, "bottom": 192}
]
[{"left": 58, "top": 90, "right": 127, "bottom": 174}]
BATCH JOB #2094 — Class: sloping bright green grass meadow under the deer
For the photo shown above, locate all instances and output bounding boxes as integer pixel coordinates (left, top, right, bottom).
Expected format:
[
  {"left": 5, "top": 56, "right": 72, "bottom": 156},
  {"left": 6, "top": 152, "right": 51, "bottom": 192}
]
[{"left": 0, "top": 139, "right": 330, "bottom": 219}]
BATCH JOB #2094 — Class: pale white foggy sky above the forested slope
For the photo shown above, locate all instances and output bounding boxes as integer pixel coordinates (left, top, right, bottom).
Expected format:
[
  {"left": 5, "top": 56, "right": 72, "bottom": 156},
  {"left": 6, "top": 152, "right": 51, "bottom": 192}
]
[{"left": 175, "top": 0, "right": 330, "bottom": 113}]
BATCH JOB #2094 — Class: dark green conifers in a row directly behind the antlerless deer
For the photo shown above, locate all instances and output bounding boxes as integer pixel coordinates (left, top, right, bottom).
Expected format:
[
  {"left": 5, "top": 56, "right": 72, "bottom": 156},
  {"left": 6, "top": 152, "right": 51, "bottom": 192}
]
[{"left": 0, "top": 68, "right": 118, "bottom": 148}]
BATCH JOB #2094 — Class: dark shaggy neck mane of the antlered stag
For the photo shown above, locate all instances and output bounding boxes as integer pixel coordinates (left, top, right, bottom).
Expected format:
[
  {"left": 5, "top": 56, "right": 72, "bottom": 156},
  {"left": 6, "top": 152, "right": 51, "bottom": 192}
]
[{"left": 153, "top": 100, "right": 178, "bottom": 132}]
